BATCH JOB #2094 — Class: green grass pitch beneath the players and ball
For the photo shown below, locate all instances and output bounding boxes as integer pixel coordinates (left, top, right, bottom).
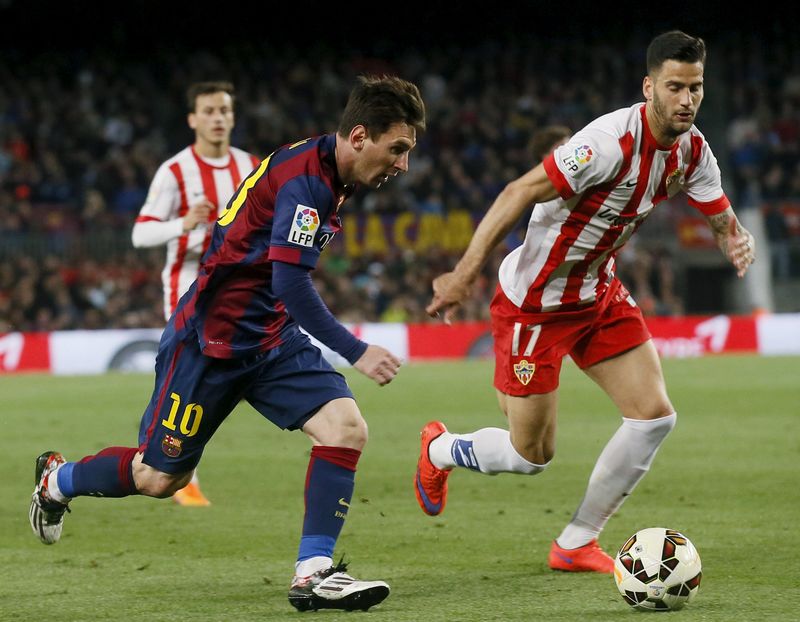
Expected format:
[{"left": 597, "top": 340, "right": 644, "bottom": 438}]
[{"left": 0, "top": 356, "right": 800, "bottom": 622}]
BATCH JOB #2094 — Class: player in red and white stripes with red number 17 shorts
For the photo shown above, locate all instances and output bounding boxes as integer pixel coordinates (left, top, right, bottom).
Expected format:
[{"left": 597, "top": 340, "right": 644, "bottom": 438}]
[{"left": 414, "top": 31, "right": 754, "bottom": 573}]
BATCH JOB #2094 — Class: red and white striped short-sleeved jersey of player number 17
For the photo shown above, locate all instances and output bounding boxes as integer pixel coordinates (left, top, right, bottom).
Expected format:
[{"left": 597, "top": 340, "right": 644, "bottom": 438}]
[{"left": 499, "top": 103, "right": 730, "bottom": 313}]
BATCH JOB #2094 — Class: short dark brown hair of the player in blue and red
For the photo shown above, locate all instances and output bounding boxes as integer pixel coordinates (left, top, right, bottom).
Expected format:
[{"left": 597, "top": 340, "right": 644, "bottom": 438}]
[{"left": 337, "top": 75, "right": 425, "bottom": 139}]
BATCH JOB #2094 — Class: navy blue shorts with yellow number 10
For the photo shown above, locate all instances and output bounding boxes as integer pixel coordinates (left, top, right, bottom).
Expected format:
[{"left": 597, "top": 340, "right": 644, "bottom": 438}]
[{"left": 139, "top": 326, "right": 353, "bottom": 474}]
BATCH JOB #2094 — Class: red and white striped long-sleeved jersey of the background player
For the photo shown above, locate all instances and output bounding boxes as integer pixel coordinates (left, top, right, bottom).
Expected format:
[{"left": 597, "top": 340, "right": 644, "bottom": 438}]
[{"left": 132, "top": 146, "right": 258, "bottom": 320}]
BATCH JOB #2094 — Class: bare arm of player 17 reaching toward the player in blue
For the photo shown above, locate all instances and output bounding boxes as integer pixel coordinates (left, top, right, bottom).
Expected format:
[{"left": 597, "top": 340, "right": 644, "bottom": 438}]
[{"left": 426, "top": 164, "right": 558, "bottom": 324}]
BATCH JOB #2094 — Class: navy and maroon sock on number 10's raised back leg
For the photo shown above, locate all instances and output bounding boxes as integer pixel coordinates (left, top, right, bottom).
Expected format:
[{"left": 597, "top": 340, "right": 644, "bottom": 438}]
[{"left": 58, "top": 447, "right": 139, "bottom": 498}]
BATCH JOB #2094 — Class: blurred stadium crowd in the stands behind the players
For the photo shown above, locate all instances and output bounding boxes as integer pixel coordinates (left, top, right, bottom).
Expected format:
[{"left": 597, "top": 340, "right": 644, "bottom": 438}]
[{"left": 0, "top": 26, "right": 800, "bottom": 332}]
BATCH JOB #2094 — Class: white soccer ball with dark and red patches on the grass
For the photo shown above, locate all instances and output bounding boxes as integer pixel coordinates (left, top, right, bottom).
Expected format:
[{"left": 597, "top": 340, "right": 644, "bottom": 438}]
[{"left": 614, "top": 527, "right": 703, "bottom": 611}]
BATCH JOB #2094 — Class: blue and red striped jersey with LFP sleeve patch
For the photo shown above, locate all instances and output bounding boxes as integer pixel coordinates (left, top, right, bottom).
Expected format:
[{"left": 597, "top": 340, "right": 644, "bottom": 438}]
[{"left": 173, "top": 134, "right": 353, "bottom": 358}]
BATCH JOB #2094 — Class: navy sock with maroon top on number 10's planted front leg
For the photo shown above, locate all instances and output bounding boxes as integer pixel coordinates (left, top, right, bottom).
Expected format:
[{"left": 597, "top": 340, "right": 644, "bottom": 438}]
[{"left": 297, "top": 445, "right": 361, "bottom": 561}]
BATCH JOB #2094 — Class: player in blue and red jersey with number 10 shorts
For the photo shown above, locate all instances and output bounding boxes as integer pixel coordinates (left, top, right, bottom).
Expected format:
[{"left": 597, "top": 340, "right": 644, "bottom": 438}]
[{"left": 30, "top": 76, "right": 425, "bottom": 610}]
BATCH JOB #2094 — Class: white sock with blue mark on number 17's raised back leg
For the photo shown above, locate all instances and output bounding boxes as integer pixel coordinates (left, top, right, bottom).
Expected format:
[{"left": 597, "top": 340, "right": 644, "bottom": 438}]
[{"left": 429, "top": 428, "right": 547, "bottom": 475}]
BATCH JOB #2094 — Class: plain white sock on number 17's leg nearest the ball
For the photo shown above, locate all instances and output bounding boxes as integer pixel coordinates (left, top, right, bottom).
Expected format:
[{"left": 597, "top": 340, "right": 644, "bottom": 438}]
[{"left": 556, "top": 413, "right": 677, "bottom": 549}]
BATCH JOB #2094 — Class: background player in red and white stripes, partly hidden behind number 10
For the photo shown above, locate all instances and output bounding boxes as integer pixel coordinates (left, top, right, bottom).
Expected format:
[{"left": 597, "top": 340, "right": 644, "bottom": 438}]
[{"left": 131, "top": 82, "right": 258, "bottom": 506}]
